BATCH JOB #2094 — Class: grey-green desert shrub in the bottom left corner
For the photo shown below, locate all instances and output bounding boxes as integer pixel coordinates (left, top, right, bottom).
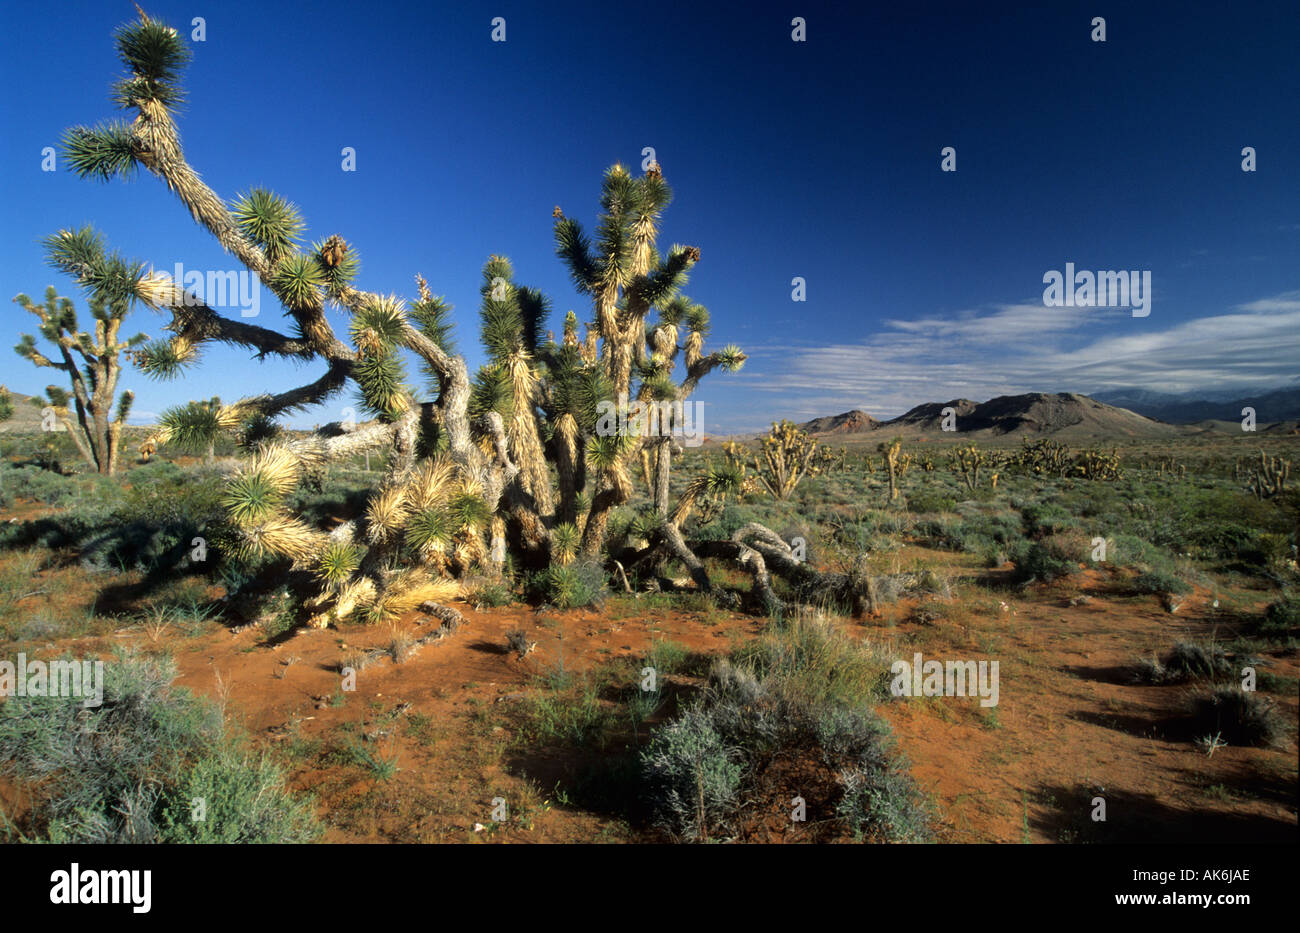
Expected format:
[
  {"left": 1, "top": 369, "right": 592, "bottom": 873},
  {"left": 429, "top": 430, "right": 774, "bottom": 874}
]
[{"left": 0, "top": 654, "right": 315, "bottom": 843}]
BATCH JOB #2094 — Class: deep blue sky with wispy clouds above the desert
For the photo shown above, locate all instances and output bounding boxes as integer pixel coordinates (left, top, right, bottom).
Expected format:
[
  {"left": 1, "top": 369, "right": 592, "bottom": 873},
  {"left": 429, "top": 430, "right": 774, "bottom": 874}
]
[{"left": 0, "top": 0, "right": 1300, "bottom": 433}]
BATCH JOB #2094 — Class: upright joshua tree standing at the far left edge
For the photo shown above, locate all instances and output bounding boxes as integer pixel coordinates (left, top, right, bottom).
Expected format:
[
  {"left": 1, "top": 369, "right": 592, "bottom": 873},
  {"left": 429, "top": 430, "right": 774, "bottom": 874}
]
[{"left": 13, "top": 284, "right": 148, "bottom": 474}]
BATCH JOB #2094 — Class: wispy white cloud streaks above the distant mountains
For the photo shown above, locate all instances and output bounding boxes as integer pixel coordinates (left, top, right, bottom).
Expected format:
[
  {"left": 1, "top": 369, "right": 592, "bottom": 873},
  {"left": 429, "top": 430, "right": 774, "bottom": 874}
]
[{"left": 732, "top": 291, "right": 1300, "bottom": 430}]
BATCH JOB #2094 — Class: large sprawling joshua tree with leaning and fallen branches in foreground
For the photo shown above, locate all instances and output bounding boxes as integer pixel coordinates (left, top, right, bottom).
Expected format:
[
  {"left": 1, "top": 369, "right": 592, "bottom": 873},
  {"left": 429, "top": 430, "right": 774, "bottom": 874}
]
[{"left": 51, "top": 12, "right": 883, "bottom": 625}]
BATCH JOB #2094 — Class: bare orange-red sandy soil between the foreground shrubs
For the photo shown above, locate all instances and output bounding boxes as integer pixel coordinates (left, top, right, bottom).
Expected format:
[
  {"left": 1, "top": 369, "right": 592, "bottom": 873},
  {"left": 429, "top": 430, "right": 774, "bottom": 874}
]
[{"left": 0, "top": 545, "right": 1300, "bottom": 842}]
